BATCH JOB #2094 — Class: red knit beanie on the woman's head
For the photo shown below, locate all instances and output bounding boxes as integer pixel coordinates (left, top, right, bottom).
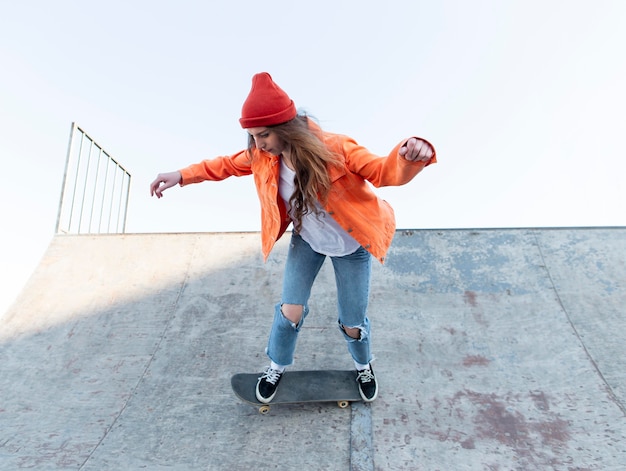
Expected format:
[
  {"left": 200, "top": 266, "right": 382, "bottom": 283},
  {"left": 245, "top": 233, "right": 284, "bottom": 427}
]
[{"left": 239, "top": 72, "right": 297, "bottom": 129}]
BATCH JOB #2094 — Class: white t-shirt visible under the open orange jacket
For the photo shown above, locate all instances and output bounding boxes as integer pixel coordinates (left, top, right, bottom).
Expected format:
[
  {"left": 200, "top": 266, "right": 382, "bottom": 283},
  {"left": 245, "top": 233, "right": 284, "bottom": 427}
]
[{"left": 278, "top": 159, "right": 361, "bottom": 257}]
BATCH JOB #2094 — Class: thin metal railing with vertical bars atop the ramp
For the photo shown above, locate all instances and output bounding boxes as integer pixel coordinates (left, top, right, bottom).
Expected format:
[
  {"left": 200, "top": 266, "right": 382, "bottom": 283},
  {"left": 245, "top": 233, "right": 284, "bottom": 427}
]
[{"left": 55, "top": 123, "right": 130, "bottom": 234}]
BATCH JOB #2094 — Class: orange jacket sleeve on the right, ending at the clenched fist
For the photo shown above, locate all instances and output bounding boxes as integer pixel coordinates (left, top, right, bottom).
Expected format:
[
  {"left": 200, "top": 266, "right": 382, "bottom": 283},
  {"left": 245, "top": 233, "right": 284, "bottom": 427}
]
[{"left": 341, "top": 136, "right": 437, "bottom": 188}]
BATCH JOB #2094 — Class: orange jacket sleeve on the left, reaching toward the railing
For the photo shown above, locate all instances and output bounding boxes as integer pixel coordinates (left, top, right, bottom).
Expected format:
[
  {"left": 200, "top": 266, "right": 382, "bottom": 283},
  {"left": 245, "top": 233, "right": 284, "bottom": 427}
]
[{"left": 180, "top": 151, "right": 252, "bottom": 186}]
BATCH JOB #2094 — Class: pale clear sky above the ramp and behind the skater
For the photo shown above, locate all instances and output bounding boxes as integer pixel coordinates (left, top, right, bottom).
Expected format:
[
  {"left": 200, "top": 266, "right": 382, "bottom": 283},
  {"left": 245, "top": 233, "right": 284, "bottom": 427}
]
[{"left": 0, "top": 0, "right": 626, "bottom": 315}]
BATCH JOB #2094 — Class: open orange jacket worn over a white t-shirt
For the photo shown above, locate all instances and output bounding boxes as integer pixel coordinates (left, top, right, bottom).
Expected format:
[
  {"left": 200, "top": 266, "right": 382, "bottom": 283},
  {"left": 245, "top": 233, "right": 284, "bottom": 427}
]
[{"left": 180, "top": 122, "right": 437, "bottom": 263}]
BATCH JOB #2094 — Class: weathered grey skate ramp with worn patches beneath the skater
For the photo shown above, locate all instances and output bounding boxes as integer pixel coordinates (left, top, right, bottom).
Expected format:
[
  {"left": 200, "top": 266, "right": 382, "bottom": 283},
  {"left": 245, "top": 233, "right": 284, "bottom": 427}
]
[{"left": 0, "top": 228, "right": 626, "bottom": 470}]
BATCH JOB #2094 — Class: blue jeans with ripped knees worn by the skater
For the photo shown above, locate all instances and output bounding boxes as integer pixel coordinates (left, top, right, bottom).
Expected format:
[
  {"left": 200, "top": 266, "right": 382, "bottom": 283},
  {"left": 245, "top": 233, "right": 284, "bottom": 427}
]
[{"left": 267, "top": 234, "right": 372, "bottom": 366}]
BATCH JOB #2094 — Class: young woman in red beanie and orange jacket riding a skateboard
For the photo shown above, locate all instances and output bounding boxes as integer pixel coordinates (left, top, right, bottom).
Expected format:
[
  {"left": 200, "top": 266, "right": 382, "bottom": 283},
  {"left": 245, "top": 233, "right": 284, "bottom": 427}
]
[{"left": 150, "top": 73, "right": 436, "bottom": 403}]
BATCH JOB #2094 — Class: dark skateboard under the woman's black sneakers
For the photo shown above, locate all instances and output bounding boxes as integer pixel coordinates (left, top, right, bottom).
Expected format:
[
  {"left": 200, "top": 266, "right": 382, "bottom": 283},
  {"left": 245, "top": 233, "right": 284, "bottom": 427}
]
[{"left": 230, "top": 370, "right": 363, "bottom": 414}]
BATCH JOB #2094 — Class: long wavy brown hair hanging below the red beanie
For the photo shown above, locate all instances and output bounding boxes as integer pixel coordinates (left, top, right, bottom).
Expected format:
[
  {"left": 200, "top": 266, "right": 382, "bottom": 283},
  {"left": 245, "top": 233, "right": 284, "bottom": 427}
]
[{"left": 248, "top": 115, "right": 341, "bottom": 232}]
